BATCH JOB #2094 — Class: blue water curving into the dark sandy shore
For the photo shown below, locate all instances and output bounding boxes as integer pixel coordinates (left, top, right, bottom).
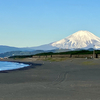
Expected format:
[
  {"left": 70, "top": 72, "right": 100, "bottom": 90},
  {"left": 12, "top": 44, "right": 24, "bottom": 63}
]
[{"left": 0, "top": 61, "right": 29, "bottom": 71}]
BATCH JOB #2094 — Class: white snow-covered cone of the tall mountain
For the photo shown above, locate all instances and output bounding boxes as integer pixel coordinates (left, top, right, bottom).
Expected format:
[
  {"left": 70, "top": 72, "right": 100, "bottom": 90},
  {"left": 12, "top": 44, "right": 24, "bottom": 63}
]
[{"left": 51, "top": 31, "right": 100, "bottom": 49}]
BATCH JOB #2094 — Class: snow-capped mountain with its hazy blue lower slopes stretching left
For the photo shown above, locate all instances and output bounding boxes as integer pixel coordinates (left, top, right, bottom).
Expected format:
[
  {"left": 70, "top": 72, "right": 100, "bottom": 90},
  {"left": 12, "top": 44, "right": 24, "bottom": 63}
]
[{"left": 0, "top": 31, "right": 100, "bottom": 53}]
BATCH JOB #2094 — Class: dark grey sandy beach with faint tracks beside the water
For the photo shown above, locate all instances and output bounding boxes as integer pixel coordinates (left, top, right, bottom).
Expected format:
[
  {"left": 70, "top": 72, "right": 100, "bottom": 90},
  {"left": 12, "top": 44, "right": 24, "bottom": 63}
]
[{"left": 0, "top": 58, "right": 100, "bottom": 100}]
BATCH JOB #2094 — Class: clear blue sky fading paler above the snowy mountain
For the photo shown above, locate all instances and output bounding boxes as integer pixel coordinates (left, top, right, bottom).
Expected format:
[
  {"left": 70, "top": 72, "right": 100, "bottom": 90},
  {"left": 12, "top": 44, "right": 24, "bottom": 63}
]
[{"left": 0, "top": 0, "right": 100, "bottom": 47}]
